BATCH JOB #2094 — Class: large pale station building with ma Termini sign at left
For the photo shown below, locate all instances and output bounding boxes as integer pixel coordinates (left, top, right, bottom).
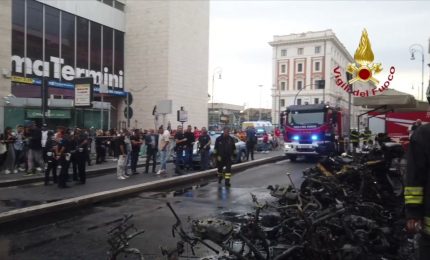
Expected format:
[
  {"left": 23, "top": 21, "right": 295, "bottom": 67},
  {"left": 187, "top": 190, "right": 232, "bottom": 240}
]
[{"left": 0, "top": 0, "right": 209, "bottom": 129}]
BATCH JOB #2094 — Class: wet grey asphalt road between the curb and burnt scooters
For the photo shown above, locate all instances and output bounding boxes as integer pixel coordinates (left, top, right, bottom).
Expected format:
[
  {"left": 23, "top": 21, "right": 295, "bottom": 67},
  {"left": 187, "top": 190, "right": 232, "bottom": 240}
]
[{"left": 0, "top": 157, "right": 314, "bottom": 260}]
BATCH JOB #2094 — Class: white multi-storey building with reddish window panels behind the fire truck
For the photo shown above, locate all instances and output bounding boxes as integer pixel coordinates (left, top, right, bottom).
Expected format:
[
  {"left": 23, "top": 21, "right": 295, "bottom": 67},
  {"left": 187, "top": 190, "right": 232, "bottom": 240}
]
[{"left": 269, "top": 30, "right": 367, "bottom": 128}]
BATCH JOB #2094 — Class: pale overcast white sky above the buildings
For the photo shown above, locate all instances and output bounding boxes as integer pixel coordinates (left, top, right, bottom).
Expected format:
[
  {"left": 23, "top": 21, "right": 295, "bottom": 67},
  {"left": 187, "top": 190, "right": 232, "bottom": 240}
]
[{"left": 208, "top": 0, "right": 430, "bottom": 108}]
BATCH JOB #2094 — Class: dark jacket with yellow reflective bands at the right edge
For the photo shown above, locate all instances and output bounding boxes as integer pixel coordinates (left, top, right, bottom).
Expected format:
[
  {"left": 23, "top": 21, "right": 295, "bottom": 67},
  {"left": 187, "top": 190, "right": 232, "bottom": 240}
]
[{"left": 404, "top": 124, "right": 430, "bottom": 235}]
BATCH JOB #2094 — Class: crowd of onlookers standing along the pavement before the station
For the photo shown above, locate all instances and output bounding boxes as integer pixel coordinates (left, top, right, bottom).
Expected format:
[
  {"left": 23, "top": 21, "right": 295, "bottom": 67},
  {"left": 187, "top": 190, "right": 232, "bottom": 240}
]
[{"left": 0, "top": 122, "right": 282, "bottom": 188}]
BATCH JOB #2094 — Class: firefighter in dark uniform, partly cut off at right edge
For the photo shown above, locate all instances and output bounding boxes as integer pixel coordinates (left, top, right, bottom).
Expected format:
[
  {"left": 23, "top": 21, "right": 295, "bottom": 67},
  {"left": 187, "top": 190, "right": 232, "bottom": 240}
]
[{"left": 404, "top": 88, "right": 430, "bottom": 260}]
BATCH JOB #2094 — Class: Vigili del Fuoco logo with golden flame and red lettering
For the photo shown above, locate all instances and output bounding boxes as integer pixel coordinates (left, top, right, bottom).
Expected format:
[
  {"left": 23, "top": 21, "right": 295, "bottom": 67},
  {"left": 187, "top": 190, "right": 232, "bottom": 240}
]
[{"left": 333, "top": 29, "right": 396, "bottom": 97}]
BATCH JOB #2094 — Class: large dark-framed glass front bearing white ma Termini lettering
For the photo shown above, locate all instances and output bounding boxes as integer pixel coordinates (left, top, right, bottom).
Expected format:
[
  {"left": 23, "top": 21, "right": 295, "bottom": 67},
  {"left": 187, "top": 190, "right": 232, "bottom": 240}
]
[{"left": 12, "top": 0, "right": 126, "bottom": 98}]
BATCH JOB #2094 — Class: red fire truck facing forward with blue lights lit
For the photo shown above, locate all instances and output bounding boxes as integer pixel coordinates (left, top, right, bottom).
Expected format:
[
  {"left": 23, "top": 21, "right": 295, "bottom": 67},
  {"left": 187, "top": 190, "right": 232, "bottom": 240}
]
[{"left": 281, "top": 104, "right": 347, "bottom": 161}]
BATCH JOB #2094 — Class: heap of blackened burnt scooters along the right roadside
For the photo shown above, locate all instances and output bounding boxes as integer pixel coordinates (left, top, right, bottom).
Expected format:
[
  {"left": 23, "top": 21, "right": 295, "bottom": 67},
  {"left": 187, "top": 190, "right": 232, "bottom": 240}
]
[{"left": 164, "top": 143, "right": 415, "bottom": 260}]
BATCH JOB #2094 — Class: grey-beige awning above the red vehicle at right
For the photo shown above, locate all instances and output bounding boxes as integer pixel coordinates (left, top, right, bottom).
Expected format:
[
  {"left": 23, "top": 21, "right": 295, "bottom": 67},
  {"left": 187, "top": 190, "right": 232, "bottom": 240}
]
[{"left": 353, "top": 89, "right": 417, "bottom": 109}]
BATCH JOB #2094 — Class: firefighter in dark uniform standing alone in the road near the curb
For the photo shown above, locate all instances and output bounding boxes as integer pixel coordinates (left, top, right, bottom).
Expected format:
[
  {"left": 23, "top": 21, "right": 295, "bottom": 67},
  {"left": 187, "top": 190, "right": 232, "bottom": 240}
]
[{"left": 214, "top": 127, "right": 236, "bottom": 187}]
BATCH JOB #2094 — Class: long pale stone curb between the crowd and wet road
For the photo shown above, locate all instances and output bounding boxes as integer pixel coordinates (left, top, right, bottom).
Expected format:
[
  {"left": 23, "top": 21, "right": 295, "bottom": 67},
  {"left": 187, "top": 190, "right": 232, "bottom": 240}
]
[{"left": 0, "top": 155, "right": 285, "bottom": 225}]
